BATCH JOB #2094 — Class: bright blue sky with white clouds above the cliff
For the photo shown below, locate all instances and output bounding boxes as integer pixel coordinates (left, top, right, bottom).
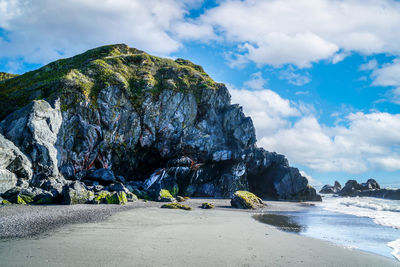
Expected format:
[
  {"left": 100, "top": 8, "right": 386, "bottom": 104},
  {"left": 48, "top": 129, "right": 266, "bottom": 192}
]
[{"left": 0, "top": 0, "right": 400, "bottom": 186}]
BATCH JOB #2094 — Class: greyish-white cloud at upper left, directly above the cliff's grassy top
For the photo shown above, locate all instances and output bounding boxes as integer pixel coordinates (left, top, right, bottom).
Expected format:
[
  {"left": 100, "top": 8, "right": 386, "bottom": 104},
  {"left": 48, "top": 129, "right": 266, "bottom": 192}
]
[{"left": 0, "top": 0, "right": 198, "bottom": 63}]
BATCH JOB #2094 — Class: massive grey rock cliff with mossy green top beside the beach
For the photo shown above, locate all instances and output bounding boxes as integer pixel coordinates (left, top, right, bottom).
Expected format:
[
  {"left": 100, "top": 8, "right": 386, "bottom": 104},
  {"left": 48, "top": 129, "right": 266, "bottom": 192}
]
[{"left": 0, "top": 45, "right": 320, "bottom": 203}]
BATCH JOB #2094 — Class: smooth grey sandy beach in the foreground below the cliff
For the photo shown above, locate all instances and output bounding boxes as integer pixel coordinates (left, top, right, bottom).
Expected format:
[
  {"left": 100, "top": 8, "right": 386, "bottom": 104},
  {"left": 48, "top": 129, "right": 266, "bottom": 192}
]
[{"left": 0, "top": 199, "right": 400, "bottom": 266}]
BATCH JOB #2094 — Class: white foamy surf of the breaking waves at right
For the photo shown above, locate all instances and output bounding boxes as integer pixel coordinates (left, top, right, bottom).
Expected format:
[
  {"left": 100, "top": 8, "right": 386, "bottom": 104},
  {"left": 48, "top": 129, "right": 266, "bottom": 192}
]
[{"left": 321, "top": 196, "right": 400, "bottom": 261}]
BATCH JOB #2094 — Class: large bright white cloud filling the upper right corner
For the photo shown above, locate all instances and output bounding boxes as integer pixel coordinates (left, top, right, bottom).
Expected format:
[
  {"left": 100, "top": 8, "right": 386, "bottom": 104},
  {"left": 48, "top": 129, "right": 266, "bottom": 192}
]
[{"left": 188, "top": 0, "right": 400, "bottom": 68}]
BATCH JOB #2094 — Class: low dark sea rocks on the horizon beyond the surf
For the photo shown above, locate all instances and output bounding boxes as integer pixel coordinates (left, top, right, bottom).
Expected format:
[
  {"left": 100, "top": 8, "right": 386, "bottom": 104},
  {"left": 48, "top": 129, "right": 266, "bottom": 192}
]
[{"left": 319, "top": 179, "right": 400, "bottom": 200}]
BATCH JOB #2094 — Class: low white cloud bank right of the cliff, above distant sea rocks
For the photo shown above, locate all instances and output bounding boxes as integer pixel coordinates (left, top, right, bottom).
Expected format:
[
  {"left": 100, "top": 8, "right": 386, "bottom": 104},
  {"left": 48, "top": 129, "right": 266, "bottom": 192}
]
[{"left": 230, "top": 78, "right": 400, "bottom": 174}]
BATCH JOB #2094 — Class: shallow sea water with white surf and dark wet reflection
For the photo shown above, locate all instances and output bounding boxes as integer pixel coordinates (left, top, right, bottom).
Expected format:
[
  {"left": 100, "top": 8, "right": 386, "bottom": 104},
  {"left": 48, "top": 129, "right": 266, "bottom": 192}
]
[{"left": 256, "top": 195, "right": 400, "bottom": 261}]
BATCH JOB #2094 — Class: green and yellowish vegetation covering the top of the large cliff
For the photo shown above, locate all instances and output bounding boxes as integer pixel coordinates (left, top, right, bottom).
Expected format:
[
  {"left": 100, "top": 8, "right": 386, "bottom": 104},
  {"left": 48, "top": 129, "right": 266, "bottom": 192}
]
[{"left": 0, "top": 44, "right": 219, "bottom": 119}]
